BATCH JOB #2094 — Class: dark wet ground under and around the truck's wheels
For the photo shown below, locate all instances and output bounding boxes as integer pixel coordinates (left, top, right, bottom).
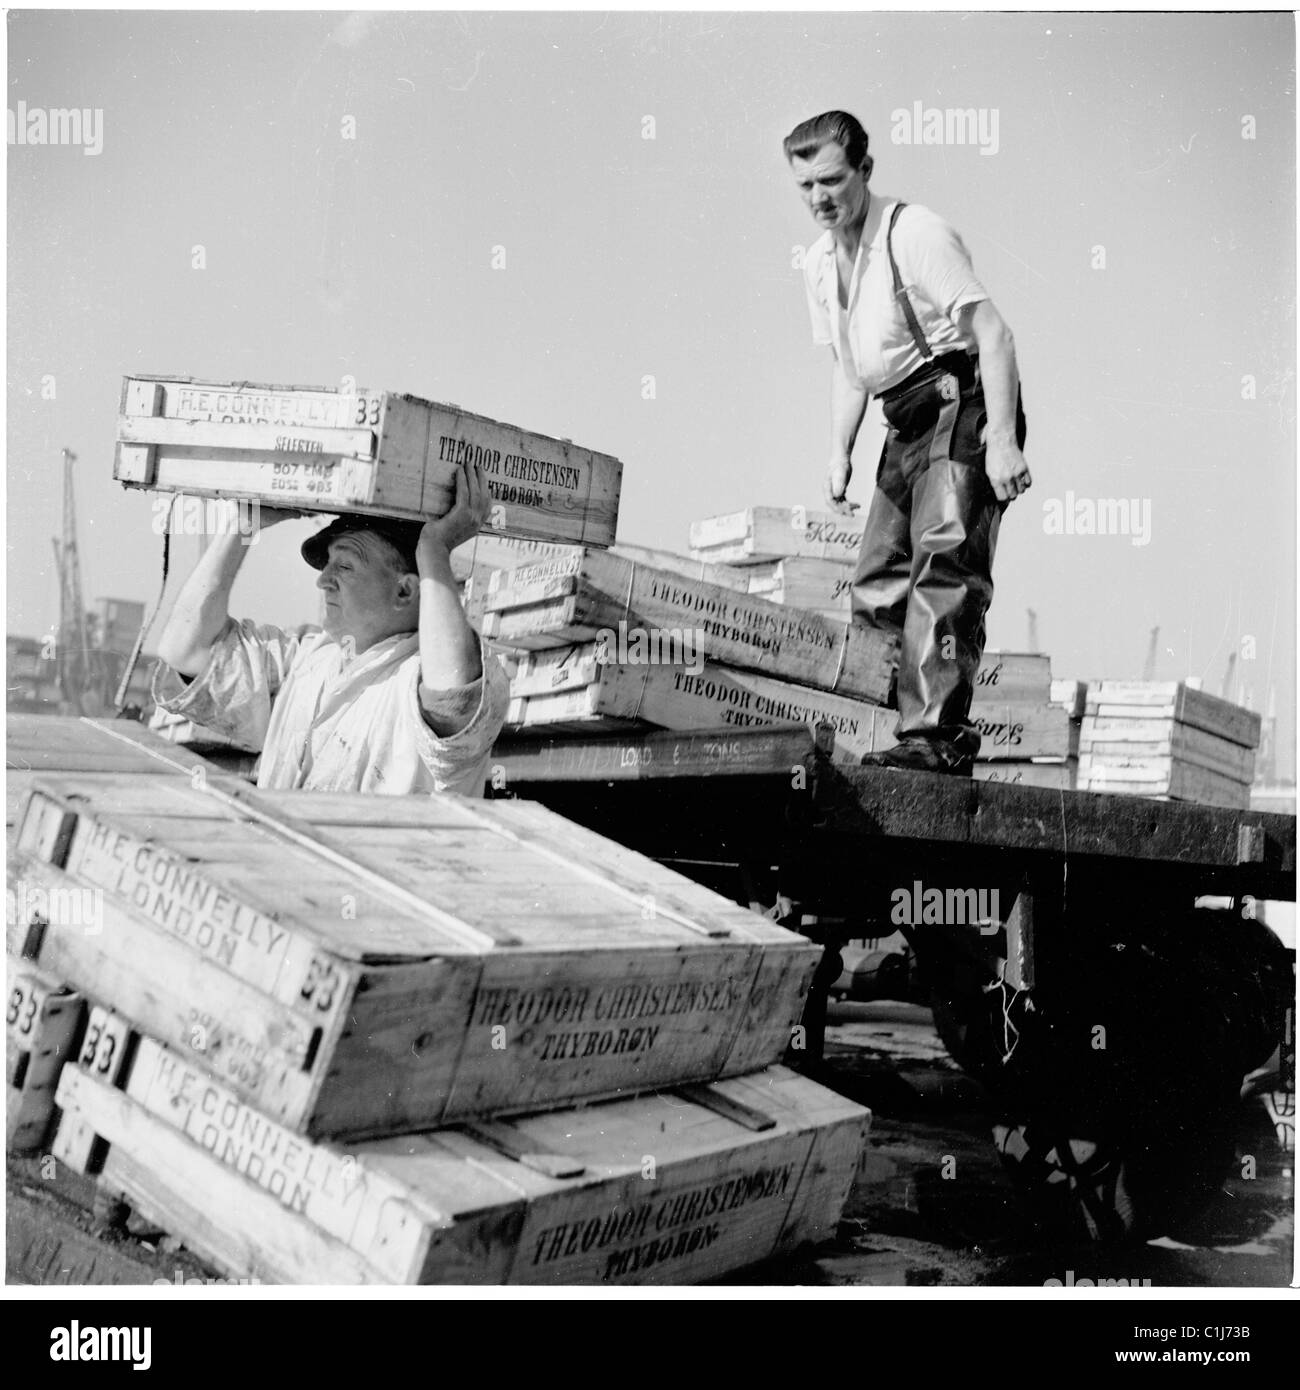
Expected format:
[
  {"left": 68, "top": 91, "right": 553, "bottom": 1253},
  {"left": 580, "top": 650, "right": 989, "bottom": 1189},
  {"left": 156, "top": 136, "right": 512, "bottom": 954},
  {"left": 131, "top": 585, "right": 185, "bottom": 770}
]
[{"left": 726, "top": 1004, "right": 1294, "bottom": 1289}]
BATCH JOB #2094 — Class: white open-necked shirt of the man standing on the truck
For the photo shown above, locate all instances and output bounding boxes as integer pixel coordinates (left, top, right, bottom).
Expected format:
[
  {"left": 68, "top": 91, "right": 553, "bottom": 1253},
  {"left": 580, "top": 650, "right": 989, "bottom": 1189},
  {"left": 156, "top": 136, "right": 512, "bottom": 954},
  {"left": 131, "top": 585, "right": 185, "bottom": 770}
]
[{"left": 804, "top": 193, "right": 989, "bottom": 395}]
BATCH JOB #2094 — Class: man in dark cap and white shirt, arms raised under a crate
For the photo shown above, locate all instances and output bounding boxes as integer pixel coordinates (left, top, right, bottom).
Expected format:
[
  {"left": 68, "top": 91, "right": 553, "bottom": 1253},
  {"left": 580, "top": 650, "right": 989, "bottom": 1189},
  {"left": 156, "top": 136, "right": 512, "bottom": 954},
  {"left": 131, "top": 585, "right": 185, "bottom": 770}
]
[{"left": 154, "top": 464, "right": 509, "bottom": 796}]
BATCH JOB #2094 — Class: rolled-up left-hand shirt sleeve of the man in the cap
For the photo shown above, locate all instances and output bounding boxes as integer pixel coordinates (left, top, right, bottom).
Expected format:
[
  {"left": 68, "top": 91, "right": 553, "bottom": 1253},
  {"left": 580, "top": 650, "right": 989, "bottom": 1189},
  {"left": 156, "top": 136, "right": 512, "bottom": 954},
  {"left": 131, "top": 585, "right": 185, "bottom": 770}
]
[{"left": 153, "top": 619, "right": 316, "bottom": 752}]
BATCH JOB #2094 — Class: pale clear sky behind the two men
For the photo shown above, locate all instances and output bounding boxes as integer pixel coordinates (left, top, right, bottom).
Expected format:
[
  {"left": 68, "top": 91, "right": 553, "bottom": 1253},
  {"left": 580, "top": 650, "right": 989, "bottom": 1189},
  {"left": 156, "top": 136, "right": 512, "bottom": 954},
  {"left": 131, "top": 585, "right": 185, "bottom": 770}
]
[{"left": 7, "top": 11, "right": 1296, "bottom": 765}]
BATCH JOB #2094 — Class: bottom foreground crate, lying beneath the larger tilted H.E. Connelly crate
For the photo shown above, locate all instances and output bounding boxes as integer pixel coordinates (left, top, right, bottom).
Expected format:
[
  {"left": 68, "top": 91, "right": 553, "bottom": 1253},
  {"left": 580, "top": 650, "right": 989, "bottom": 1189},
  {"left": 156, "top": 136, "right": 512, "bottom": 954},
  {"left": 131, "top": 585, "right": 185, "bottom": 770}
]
[{"left": 58, "top": 1038, "right": 870, "bottom": 1286}]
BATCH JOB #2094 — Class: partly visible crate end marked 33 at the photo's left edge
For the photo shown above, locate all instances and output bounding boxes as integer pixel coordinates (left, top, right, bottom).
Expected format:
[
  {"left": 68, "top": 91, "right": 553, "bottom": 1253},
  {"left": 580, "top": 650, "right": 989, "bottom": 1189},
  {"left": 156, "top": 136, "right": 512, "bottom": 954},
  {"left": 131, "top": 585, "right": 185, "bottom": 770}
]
[{"left": 4, "top": 956, "right": 85, "bottom": 1154}]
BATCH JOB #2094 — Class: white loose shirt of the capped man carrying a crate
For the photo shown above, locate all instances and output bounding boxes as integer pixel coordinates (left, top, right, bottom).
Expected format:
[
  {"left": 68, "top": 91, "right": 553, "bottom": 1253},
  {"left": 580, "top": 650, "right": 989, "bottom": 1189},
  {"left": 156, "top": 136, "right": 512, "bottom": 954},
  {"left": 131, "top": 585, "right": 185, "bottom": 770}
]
[{"left": 154, "top": 619, "right": 509, "bottom": 796}]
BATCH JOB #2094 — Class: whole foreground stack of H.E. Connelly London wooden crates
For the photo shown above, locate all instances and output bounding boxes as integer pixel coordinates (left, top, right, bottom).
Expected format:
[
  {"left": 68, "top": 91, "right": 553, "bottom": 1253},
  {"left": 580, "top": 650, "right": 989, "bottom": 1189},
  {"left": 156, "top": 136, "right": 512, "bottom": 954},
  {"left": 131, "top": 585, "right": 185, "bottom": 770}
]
[{"left": 7, "top": 717, "right": 869, "bottom": 1284}]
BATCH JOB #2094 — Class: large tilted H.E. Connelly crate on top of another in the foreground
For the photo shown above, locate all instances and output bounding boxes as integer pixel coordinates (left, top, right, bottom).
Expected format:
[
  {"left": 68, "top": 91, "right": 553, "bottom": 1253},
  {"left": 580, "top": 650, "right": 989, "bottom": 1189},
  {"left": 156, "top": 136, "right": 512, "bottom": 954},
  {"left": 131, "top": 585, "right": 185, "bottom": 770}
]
[{"left": 15, "top": 777, "right": 818, "bottom": 1136}]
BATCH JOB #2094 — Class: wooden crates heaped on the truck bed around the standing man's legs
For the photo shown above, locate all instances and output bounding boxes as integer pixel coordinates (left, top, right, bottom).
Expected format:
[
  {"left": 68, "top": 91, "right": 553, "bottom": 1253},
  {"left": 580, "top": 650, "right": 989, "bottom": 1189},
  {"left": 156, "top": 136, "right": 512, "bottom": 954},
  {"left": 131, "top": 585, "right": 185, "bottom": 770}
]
[{"left": 472, "top": 507, "right": 1078, "bottom": 787}]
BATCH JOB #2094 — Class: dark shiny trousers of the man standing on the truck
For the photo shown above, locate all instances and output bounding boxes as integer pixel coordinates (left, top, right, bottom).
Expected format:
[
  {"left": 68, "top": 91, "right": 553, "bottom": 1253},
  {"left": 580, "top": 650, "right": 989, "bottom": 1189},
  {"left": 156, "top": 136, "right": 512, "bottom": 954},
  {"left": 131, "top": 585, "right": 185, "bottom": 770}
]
[{"left": 852, "top": 353, "right": 1025, "bottom": 756}]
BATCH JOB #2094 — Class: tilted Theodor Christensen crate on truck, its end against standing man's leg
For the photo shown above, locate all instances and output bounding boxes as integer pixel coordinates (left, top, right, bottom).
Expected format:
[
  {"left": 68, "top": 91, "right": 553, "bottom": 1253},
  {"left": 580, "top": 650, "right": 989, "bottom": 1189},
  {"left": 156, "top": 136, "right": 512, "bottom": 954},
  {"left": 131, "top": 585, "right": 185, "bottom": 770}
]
[{"left": 482, "top": 548, "right": 898, "bottom": 703}]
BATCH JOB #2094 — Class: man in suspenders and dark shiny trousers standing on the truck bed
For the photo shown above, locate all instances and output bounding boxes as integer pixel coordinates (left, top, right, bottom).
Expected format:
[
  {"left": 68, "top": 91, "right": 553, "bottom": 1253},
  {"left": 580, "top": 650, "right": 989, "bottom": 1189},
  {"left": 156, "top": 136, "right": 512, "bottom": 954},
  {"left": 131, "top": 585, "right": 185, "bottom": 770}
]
[{"left": 784, "top": 111, "right": 1030, "bottom": 776}]
